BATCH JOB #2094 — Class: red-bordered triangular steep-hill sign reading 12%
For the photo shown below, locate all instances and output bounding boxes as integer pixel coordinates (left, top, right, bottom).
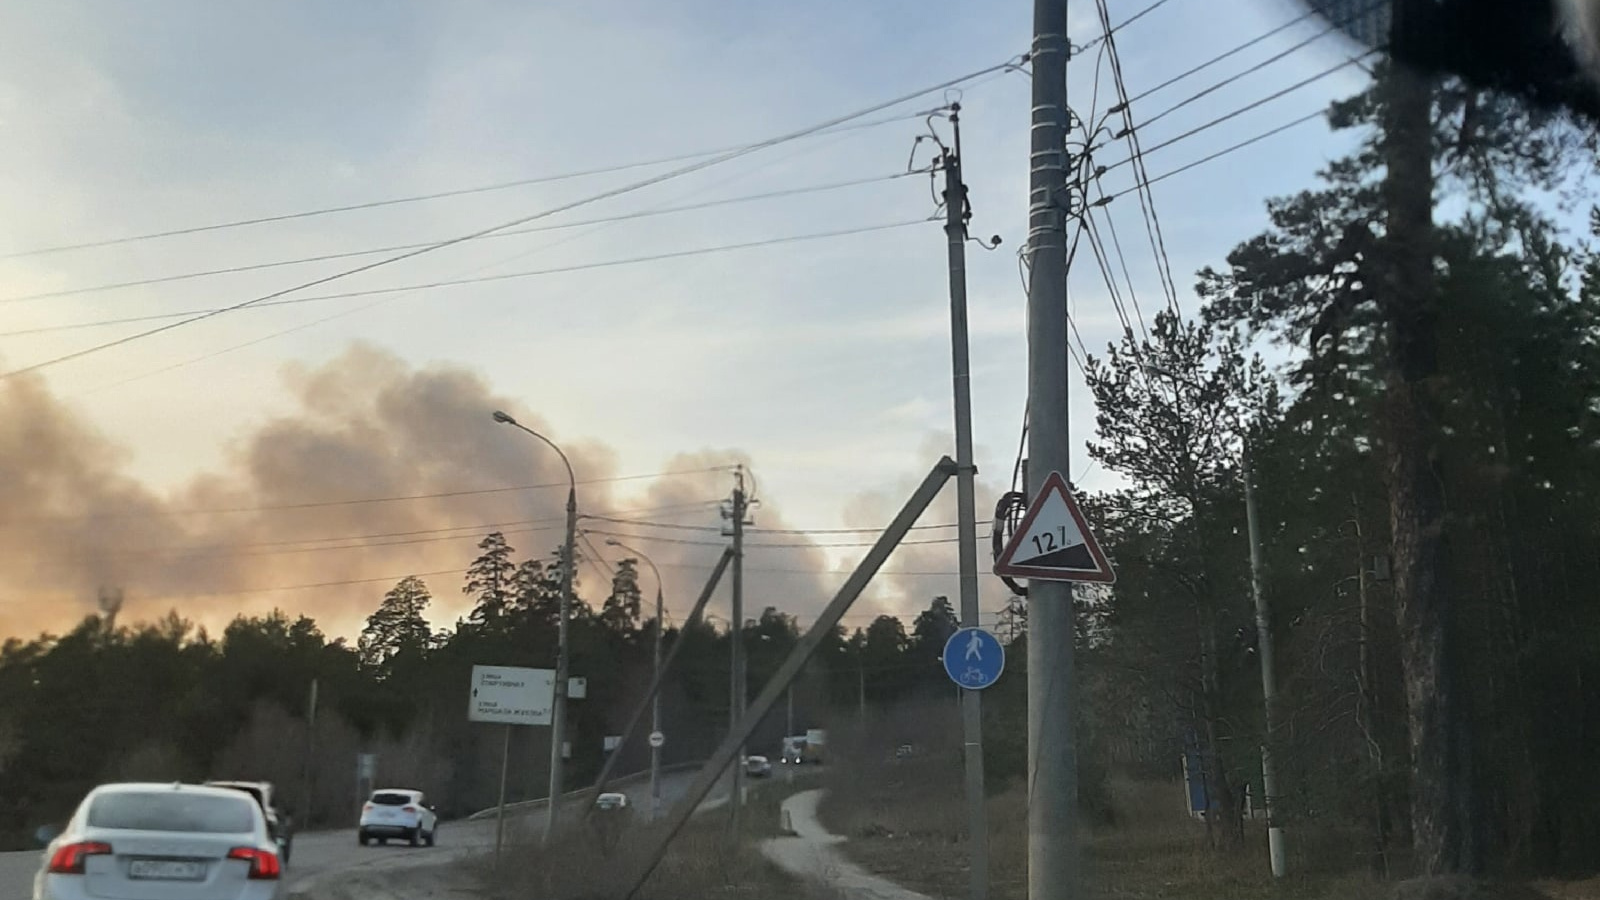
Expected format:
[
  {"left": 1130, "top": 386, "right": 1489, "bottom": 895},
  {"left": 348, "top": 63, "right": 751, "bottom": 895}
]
[{"left": 995, "top": 472, "right": 1117, "bottom": 585}]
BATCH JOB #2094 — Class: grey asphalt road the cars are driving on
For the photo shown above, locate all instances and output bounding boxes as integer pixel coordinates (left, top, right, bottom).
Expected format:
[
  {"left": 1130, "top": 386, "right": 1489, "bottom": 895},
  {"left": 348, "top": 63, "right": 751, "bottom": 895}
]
[{"left": 0, "top": 762, "right": 720, "bottom": 900}]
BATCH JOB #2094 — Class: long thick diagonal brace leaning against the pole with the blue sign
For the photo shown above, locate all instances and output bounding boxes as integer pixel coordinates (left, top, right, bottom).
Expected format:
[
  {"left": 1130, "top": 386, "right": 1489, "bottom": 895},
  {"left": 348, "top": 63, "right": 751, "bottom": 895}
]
[{"left": 622, "top": 456, "right": 955, "bottom": 900}]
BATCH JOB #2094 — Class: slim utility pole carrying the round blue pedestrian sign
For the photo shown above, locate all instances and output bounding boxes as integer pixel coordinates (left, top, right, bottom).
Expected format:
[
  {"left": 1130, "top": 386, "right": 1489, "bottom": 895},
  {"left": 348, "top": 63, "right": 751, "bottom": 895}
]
[{"left": 939, "top": 102, "right": 989, "bottom": 900}]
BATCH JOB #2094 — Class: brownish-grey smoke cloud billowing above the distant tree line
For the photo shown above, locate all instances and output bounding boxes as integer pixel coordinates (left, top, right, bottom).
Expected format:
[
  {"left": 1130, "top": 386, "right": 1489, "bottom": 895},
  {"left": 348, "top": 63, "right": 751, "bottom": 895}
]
[{"left": 0, "top": 346, "right": 830, "bottom": 634}]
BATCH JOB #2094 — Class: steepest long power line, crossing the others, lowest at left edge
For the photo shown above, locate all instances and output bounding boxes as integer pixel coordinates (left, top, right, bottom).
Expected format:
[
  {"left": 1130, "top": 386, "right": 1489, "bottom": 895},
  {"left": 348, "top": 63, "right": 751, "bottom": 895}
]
[{"left": 0, "top": 61, "right": 1010, "bottom": 380}]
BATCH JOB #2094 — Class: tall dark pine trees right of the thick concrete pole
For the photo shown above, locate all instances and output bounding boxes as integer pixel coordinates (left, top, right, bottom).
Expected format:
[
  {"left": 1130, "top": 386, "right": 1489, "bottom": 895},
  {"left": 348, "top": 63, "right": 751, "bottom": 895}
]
[{"left": 1056, "top": 69, "right": 1600, "bottom": 874}]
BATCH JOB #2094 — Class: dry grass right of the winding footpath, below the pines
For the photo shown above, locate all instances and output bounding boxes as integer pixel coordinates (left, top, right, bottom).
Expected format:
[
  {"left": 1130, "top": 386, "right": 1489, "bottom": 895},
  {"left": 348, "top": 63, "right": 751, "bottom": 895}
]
[{"left": 819, "top": 756, "right": 1600, "bottom": 900}]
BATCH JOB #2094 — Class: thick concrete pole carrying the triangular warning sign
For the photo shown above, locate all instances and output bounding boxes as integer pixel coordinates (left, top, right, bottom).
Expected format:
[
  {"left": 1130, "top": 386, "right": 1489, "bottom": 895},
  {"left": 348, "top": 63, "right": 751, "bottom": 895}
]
[{"left": 1027, "top": 0, "right": 1080, "bottom": 900}]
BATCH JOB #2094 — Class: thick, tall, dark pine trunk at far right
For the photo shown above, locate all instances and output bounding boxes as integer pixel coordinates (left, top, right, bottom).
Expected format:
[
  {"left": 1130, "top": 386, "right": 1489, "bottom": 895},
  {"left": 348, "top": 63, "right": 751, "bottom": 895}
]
[{"left": 1381, "top": 59, "right": 1475, "bottom": 876}]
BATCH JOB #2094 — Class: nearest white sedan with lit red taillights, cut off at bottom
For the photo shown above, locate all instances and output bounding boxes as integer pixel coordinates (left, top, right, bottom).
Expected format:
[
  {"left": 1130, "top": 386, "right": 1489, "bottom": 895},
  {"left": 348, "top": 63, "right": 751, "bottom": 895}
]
[{"left": 34, "top": 783, "right": 283, "bottom": 900}]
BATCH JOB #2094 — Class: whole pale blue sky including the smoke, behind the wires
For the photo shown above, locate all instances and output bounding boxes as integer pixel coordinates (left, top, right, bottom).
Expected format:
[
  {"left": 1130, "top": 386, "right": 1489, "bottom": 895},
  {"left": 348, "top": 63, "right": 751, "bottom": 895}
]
[{"left": 0, "top": 0, "right": 1363, "bottom": 634}]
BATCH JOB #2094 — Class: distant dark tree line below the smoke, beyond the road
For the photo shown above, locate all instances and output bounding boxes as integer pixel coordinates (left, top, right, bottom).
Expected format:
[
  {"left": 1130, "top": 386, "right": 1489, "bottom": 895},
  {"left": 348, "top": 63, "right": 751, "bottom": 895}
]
[{"left": 0, "top": 532, "right": 955, "bottom": 849}]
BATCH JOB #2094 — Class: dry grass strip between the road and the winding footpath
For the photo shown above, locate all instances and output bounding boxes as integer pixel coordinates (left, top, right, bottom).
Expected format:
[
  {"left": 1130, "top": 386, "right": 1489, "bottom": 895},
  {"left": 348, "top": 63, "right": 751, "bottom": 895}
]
[{"left": 474, "top": 778, "right": 837, "bottom": 900}]
